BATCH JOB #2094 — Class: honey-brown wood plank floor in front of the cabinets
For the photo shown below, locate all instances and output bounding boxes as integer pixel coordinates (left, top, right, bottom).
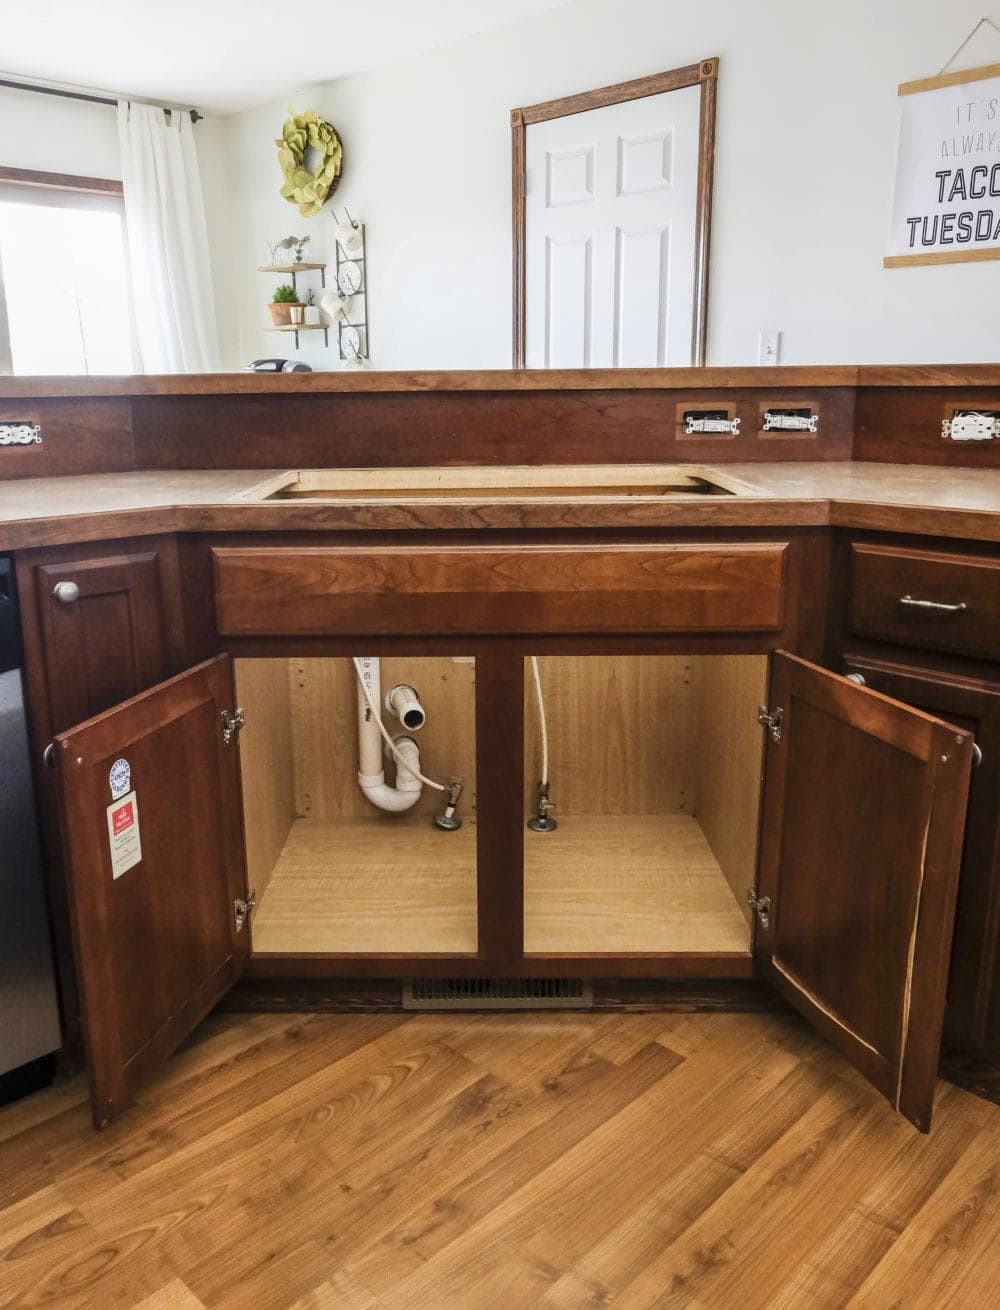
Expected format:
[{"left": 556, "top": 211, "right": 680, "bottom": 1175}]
[{"left": 0, "top": 1014, "right": 1000, "bottom": 1310}]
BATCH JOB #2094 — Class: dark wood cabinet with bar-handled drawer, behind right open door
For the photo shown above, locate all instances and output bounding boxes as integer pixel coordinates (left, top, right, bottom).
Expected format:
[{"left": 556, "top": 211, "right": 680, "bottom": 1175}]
[{"left": 831, "top": 534, "right": 1000, "bottom": 1065}]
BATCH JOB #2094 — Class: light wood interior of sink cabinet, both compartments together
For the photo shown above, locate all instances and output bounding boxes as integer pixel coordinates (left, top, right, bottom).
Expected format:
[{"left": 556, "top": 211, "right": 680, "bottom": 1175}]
[{"left": 241, "top": 655, "right": 767, "bottom": 955}]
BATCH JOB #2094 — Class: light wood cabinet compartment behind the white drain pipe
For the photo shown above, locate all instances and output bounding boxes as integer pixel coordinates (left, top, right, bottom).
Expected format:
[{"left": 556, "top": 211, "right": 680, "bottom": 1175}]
[{"left": 235, "top": 656, "right": 477, "bottom": 955}]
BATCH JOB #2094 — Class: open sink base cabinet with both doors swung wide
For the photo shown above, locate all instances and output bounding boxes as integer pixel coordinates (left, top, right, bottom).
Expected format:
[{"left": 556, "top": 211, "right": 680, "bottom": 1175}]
[{"left": 41, "top": 544, "right": 972, "bottom": 1128}]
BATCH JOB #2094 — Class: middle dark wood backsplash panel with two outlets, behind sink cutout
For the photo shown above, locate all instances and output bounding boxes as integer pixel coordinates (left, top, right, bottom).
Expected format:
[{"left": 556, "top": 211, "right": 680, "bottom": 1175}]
[{"left": 132, "top": 380, "right": 855, "bottom": 469}]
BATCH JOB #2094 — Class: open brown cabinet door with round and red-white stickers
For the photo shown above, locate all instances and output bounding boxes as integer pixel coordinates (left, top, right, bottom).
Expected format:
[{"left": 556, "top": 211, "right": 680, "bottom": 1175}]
[{"left": 55, "top": 655, "right": 249, "bottom": 1128}]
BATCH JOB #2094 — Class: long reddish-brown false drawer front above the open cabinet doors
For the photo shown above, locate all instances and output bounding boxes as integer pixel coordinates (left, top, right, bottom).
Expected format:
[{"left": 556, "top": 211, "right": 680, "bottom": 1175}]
[{"left": 212, "top": 542, "right": 788, "bottom": 637}]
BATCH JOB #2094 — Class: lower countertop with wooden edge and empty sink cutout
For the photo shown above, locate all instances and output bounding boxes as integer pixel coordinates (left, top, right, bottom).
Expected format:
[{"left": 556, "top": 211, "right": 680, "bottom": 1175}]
[{"left": 0, "top": 462, "right": 1000, "bottom": 550}]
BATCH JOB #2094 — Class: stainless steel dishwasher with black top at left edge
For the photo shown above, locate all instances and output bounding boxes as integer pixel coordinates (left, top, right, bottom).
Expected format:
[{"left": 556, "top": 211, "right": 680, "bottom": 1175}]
[{"left": 0, "top": 557, "right": 59, "bottom": 1104}]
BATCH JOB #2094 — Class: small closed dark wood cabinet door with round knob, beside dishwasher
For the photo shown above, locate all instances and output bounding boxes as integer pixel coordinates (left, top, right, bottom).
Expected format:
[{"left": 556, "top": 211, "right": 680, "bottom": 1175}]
[{"left": 34, "top": 549, "right": 180, "bottom": 732}]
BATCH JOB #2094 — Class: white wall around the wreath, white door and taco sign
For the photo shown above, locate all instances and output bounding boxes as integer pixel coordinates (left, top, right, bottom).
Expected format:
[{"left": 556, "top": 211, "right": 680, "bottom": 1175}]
[{"left": 214, "top": 0, "right": 1000, "bottom": 368}]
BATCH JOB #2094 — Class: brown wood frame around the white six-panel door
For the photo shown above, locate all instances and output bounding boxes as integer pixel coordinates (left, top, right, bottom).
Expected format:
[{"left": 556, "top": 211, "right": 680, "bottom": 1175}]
[{"left": 510, "top": 58, "right": 720, "bottom": 368}]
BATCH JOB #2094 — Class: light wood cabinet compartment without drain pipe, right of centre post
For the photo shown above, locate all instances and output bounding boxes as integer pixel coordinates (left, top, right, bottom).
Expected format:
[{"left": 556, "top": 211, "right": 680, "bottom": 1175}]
[{"left": 524, "top": 655, "right": 767, "bottom": 955}]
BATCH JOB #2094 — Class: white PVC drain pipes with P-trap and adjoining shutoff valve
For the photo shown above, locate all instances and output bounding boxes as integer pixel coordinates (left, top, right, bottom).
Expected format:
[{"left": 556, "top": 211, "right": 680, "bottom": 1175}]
[{"left": 354, "top": 655, "right": 461, "bottom": 832}]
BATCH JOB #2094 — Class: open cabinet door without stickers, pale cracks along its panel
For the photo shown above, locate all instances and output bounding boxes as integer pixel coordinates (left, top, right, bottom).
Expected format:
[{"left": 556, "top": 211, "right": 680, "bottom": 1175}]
[{"left": 754, "top": 651, "right": 972, "bottom": 1132}]
